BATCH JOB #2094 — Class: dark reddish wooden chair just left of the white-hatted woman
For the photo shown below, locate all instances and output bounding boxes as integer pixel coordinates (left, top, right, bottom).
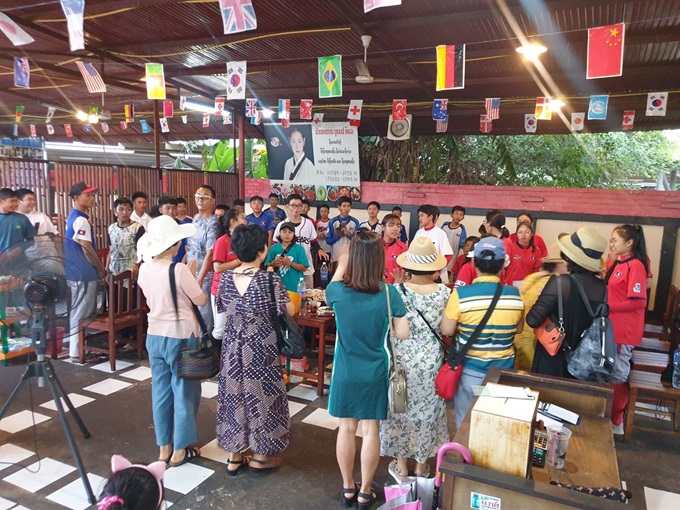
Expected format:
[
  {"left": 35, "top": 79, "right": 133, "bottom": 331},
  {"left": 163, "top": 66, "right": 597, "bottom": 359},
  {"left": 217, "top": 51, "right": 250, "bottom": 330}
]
[{"left": 79, "top": 271, "right": 144, "bottom": 370}]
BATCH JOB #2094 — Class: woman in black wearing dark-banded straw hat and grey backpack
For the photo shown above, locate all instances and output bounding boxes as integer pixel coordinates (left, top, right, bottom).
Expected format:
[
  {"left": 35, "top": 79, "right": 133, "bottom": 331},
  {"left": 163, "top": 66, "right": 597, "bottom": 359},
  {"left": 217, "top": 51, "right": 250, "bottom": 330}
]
[{"left": 526, "top": 227, "right": 609, "bottom": 378}]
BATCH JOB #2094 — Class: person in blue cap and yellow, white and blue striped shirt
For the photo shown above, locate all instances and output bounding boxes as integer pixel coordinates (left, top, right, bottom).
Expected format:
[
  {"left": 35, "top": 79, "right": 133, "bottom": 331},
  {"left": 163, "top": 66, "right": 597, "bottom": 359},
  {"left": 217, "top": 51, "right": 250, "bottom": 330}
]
[{"left": 441, "top": 237, "right": 524, "bottom": 428}]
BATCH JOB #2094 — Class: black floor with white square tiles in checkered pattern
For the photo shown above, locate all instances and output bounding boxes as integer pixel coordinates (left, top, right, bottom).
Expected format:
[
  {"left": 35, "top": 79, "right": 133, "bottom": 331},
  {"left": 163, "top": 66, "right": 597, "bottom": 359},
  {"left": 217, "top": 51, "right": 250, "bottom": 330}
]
[{"left": 0, "top": 350, "right": 680, "bottom": 510}]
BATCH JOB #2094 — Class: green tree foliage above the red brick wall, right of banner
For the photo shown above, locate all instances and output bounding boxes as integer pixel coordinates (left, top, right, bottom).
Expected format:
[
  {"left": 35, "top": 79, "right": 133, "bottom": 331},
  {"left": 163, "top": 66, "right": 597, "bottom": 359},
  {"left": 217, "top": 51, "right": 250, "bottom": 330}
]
[{"left": 360, "top": 131, "right": 680, "bottom": 188}]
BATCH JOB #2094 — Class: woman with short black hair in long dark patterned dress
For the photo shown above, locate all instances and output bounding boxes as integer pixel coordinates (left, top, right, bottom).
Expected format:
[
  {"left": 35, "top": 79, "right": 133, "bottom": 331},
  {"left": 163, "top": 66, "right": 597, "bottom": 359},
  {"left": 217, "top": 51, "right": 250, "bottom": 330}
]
[{"left": 217, "top": 225, "right": 293, "bottom": 476}]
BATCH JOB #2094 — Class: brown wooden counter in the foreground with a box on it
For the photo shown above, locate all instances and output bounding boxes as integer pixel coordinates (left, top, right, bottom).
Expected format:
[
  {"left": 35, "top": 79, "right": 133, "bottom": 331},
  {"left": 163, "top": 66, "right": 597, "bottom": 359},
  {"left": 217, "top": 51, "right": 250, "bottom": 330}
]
[{"left": 441, "top": 369, "right": 621, "bottom": 510}]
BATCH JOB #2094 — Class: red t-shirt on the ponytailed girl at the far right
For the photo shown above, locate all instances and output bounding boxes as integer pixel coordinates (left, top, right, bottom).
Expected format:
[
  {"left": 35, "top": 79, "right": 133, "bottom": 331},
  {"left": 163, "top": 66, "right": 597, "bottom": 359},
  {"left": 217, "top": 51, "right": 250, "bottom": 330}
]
[{"left": 607, "top": 255, "right": 647, "bottom": 345}]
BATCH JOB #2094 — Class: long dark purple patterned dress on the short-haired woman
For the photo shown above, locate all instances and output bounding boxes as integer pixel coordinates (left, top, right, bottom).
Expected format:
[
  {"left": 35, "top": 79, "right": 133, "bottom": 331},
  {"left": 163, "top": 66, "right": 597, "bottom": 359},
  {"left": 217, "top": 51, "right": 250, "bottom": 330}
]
[{"left": 217, "top": 271, "right": 291, "bottom": 456}]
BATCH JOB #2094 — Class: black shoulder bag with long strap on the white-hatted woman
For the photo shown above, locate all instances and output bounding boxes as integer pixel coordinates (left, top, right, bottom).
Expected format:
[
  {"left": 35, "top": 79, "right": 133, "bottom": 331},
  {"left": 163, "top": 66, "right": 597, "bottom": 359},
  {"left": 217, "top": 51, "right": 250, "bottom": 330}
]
[{"left": 170, "top": 263, "right": 220, "bottom": 381}]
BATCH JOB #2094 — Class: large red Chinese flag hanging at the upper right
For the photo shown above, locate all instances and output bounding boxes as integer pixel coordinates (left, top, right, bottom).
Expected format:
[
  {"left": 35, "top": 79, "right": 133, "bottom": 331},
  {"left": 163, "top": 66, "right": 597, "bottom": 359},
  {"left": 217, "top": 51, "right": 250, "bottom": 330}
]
[{"left": 586, "top": 23, "right": 625, "bottom": 80}]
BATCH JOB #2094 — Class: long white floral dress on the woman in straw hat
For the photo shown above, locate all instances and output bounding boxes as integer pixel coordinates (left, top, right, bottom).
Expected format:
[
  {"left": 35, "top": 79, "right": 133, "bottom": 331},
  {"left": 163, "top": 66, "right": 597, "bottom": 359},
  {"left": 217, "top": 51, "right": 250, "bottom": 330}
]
[{"left": 380, "top": 284, "right": 451, "bottom": 462}]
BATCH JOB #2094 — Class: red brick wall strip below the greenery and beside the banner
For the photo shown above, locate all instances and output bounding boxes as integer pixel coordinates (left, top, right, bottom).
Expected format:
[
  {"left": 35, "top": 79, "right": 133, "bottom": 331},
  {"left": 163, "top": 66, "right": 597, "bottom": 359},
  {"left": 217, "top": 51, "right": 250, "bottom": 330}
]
[{"left": 246, "top": 179, "right": 680, "bottom": 218}]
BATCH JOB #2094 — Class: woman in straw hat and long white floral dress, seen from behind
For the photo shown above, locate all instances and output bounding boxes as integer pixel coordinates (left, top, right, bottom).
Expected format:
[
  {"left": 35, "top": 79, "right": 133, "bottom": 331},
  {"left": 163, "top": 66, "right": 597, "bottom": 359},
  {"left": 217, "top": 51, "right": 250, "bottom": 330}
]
[{"left": 380, "top": 237, "right": 451, "bottom": 481}]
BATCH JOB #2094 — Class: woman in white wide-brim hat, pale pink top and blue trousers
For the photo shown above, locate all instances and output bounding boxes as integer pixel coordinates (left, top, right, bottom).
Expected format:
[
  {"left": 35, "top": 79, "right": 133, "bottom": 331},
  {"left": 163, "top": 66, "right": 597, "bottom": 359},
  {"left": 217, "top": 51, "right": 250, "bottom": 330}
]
[{"left": 137, "top": 216, "right": 207, "bottom": 466}]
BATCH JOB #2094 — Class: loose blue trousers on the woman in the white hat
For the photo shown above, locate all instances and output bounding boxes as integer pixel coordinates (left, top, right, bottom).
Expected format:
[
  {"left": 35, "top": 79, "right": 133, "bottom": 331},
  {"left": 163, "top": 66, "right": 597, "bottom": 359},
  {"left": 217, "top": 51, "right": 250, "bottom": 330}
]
[{"left": 146, "top": 335, "right": 201, "bottom": 450}]
